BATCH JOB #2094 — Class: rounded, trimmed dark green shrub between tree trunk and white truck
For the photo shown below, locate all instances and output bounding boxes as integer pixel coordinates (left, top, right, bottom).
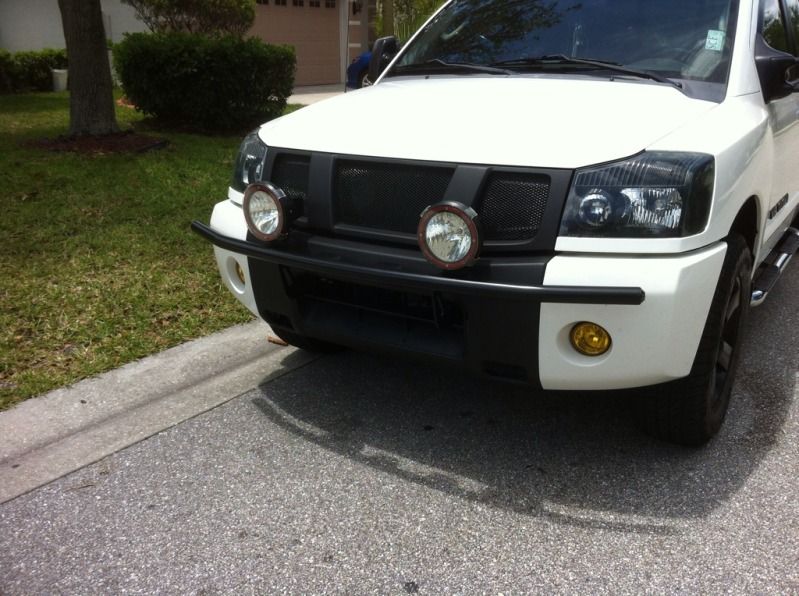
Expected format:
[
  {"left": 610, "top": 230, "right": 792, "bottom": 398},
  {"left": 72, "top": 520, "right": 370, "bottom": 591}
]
[{"left": 114, "top": 33, "right": 295, "bottom": 130}]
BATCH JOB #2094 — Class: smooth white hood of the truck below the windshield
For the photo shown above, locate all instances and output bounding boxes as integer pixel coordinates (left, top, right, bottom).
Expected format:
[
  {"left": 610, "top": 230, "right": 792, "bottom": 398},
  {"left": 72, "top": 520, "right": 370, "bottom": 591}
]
[{"left": 261, "top": 76, "right": 717, "bottom": 168}]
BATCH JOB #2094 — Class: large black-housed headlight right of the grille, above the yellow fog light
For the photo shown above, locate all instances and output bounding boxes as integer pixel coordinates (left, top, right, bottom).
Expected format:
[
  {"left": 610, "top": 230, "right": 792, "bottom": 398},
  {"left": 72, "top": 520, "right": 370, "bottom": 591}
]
[{"left": 560, "top": 151, "right": 714, "bottom": 238}]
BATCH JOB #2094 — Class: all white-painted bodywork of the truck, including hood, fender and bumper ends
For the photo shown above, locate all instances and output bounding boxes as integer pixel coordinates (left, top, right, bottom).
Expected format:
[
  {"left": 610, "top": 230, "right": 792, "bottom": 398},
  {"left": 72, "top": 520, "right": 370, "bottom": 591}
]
[{"left": 202, "top": 0, "right": 799, "bottom": 410}]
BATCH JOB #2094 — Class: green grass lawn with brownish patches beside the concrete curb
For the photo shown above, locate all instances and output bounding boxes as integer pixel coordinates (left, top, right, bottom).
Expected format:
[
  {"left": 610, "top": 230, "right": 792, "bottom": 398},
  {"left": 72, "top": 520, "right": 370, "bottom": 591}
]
[{"left": 0, "top": 93, "right": 282, "bottom": 409}]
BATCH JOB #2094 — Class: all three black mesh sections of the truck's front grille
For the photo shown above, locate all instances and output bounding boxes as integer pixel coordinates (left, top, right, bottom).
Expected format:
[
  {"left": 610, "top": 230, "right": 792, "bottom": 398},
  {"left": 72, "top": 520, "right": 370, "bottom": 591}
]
[{"left": 269, "top": 151, "right": 566, "bottom": 250}]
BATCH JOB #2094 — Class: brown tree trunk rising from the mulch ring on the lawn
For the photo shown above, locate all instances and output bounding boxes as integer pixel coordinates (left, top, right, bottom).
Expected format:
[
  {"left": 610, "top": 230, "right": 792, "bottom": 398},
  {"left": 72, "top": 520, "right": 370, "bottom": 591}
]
[{"left": 58, "top": 0, "right": 119, "bottom": 135}]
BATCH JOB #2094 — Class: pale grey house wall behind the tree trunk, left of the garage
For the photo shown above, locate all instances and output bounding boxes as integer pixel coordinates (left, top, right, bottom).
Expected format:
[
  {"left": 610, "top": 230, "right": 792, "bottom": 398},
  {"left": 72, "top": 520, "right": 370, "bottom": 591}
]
[{"left": 0, "top": 0, "right": 146, "bottom": 52}]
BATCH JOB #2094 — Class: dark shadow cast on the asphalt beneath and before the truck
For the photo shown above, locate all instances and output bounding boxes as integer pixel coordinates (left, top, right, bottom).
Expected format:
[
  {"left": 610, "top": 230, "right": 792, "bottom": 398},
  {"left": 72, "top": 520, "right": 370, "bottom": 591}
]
[{"left": 253, "top": 272, "right": 799, "bottom": 535}]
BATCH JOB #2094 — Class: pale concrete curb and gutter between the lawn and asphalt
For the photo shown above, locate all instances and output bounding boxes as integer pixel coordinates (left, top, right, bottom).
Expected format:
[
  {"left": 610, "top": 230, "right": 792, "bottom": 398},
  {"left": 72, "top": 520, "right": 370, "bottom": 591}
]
[{"left": 0, "top": 321, "right": 317, "bottom": 503}]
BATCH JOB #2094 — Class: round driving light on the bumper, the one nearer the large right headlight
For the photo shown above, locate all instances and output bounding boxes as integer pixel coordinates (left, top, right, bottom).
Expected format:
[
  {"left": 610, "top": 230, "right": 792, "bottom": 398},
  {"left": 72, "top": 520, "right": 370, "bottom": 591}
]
[{"left": 417, "top": 203, "right": 480, "bottom": 270}]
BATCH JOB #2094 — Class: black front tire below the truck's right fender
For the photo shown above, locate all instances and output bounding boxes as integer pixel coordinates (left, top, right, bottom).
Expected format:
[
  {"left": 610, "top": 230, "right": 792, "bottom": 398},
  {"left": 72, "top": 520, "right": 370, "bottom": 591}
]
[{"left": 637, "top": 234, "right": 752, "bottom": 447}]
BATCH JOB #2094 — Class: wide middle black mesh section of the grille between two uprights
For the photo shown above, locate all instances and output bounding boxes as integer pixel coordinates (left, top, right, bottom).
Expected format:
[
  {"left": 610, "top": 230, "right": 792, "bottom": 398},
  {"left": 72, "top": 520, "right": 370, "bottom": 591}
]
[{"left": 333, "top": 160, "right": 453, "bottom": 234}]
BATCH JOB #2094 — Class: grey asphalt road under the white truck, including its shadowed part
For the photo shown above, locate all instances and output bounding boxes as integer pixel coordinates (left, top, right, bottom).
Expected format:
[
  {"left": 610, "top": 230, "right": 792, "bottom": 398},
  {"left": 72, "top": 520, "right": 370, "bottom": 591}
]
[{"left": 0, "top": 264, "right": 799, "bottom": 595}]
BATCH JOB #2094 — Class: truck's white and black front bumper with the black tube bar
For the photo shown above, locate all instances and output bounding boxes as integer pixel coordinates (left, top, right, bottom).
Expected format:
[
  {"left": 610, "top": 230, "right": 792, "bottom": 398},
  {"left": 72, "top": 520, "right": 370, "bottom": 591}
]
[{"left": 192, "top": 201, "right": 726, "bottom": 389}]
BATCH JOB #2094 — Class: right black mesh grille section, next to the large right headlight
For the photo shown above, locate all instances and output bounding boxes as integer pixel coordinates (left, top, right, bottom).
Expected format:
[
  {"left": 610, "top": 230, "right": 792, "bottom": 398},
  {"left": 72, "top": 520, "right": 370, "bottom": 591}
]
[{"left": 477, "top": 172, "right": 549, "bottom": 241}]
